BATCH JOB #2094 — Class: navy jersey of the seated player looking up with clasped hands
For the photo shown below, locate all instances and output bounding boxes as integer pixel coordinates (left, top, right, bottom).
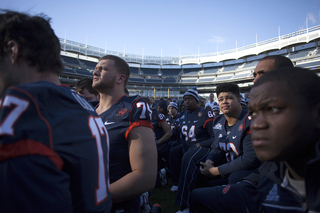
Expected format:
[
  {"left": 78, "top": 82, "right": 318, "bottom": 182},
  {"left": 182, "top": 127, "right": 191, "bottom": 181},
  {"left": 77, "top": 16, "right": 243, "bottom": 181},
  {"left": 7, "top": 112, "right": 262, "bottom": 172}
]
[{"left": 207, "top": 109, "right": 260, "bottom": 176}]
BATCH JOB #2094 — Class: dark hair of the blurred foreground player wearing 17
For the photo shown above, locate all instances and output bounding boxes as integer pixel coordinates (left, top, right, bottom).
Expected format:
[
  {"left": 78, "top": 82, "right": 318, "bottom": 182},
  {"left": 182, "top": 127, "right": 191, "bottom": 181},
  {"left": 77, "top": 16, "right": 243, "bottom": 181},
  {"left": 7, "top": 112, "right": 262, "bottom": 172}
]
[{"left": 0, "top": 10, "right": 63, "bottom": 75}]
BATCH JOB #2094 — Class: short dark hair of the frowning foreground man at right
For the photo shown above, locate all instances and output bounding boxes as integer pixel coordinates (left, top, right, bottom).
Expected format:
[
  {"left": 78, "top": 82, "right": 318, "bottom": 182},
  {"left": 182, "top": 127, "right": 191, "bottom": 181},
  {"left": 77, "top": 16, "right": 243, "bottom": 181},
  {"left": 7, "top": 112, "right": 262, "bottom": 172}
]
[{"left": 253, "top": 67, "right": 320, "bottom": 108}]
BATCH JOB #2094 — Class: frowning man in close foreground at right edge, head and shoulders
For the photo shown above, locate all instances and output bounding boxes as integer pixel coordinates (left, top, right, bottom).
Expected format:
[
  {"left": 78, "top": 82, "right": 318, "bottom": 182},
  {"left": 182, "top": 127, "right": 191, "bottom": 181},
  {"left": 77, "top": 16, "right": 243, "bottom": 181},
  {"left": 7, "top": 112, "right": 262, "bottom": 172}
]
[{"left": 249, "top": 68, "right": 320, "bottom": 213}]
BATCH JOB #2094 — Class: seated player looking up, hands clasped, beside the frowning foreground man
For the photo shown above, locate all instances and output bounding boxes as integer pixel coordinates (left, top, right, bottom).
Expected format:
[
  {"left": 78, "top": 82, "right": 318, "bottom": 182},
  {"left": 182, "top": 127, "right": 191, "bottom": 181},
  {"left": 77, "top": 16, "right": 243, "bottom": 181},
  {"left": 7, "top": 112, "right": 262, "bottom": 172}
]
[{"left": 176, "top": 83, "right": 260, "bottom": 212}]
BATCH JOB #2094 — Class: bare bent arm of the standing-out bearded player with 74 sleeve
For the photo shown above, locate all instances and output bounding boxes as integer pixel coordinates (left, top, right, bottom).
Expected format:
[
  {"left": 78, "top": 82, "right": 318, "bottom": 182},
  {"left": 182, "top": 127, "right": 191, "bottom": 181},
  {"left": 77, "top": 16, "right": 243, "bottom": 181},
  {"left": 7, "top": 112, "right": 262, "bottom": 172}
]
[{"left": 110, "top": 126, "right": 157, "bottom": 203}]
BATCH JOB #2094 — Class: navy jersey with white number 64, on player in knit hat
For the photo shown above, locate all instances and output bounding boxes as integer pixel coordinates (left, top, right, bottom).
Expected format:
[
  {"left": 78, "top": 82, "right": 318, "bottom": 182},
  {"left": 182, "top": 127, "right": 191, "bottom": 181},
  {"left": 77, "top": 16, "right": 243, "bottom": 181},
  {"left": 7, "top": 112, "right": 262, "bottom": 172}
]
[{"left": 179, "top": 107, "right": 214, "bottom": 151}]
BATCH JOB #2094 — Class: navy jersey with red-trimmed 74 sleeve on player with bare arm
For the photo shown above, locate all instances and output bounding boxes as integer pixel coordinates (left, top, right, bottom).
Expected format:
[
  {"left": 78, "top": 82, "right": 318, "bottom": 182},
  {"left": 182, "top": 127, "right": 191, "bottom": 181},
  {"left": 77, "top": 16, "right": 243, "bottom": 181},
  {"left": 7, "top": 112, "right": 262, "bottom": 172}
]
[{"left": 100, "top": 96, "right": 152, "bottom": 183}]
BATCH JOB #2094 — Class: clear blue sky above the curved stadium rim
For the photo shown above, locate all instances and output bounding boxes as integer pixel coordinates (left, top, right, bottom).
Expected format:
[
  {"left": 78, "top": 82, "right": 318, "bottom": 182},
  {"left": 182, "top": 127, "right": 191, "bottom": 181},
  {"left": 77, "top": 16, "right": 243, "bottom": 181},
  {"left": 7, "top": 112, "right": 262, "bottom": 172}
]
[{"left": 0, "top": 0, "right": 320, "bottom": 56}]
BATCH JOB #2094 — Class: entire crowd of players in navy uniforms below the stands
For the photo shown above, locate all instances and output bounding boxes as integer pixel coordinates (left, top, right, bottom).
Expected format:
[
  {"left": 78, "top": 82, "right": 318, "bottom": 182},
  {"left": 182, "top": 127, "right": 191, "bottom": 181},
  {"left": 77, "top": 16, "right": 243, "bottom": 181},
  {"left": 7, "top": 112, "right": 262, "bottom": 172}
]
[{"left": 0, "top": 11, "right": 320, "bottom": 213}]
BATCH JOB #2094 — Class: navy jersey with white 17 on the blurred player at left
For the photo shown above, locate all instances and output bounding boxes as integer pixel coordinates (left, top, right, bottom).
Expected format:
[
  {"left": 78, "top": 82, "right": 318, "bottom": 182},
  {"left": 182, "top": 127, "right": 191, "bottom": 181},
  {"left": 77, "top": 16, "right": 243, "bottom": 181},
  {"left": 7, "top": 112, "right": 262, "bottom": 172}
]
[{"left": 0, "top": 81, "right": 111, "bottom": 212}]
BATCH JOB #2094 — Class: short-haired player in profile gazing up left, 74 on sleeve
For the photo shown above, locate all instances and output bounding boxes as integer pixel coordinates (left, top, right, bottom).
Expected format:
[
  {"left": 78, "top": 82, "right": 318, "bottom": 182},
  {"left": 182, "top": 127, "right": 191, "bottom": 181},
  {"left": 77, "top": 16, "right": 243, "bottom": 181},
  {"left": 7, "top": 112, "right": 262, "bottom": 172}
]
[{"left": 92, "top": 55, "right": 157, "bottom": 212}]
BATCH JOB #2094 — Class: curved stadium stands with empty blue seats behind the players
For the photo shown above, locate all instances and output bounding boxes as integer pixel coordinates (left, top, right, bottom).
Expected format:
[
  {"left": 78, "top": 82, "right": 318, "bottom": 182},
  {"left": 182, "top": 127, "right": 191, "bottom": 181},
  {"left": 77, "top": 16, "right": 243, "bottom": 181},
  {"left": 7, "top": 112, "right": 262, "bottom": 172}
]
[{"left": 60, "top": 25, "right": 320, "bottom": 98}]
